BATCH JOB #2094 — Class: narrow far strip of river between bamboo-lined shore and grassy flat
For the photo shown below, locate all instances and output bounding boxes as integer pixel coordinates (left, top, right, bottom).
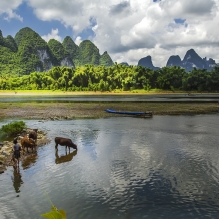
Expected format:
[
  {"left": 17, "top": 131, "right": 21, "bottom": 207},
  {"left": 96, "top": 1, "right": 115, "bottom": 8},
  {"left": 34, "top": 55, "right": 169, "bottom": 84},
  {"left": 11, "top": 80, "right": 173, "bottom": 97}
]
[{"left": 0, "top": 93, "right": 219, "bottom": 103}]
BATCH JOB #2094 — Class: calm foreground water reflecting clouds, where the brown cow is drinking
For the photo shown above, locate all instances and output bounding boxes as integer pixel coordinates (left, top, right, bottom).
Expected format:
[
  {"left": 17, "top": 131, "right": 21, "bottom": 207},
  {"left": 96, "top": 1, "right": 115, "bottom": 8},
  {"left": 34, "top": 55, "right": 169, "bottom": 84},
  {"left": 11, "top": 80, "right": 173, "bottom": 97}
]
[{"left": 0, "top": 114, "right": 219, "bottom": 219}]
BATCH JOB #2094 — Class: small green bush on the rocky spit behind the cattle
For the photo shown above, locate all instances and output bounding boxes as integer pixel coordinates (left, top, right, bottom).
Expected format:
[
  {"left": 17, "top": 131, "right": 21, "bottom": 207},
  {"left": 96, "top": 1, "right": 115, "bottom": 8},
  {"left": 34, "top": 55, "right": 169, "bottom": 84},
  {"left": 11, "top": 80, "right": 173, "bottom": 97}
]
[{"left": 1, "top": 121, "right": 26, "bottom": 136}]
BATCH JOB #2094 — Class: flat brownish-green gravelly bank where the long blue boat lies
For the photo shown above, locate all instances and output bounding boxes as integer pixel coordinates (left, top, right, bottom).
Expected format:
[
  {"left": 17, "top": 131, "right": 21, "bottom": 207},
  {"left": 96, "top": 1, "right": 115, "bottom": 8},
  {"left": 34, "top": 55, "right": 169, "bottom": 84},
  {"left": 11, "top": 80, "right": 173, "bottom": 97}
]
[{"left": 0, "top": 102, "right": 218, "bottom": 119}]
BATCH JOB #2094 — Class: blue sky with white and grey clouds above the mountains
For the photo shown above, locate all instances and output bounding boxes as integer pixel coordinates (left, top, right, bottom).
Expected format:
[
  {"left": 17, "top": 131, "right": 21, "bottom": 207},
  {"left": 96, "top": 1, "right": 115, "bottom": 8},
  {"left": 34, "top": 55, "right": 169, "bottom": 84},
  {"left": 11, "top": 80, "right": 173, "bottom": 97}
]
[{"left": 0, "top": 0, "right": 219, "bottom": 67}]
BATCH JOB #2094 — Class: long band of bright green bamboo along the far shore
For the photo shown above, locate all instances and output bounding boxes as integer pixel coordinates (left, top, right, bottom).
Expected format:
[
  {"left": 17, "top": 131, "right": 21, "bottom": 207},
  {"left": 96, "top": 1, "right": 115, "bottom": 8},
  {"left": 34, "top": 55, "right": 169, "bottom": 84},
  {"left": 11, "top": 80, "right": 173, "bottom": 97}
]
[{"left": 0, "top": 63, "right": 219, "bottom": 92}]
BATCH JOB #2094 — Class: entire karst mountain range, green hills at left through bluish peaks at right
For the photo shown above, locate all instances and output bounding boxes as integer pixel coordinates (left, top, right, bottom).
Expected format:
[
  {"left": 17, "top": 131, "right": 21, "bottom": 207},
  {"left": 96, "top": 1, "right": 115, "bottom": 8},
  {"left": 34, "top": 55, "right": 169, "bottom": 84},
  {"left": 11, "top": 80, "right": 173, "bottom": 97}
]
[{"left": 0, "top": 27, "right": 217, "bottom": 76}]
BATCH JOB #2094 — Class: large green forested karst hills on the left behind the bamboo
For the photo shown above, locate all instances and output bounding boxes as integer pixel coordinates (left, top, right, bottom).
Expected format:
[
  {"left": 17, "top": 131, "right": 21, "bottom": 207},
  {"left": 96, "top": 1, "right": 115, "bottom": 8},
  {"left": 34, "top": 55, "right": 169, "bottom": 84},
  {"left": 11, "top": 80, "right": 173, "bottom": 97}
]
[{"left": 0, "top": 27, "right": 114, "bottom": 77}]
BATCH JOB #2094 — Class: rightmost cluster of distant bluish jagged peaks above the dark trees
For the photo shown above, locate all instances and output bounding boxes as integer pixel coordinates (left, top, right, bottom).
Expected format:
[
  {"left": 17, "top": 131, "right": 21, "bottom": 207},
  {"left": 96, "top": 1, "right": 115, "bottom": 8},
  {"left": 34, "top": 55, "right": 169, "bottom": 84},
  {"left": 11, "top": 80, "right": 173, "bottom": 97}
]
[{"left": 166, "top": 49, "right": 217, "bottom": 72}]
